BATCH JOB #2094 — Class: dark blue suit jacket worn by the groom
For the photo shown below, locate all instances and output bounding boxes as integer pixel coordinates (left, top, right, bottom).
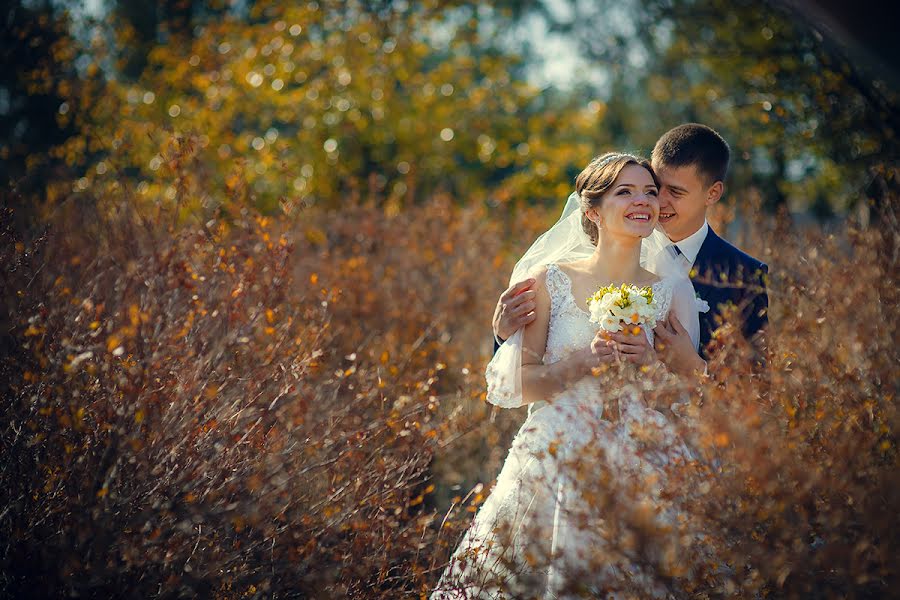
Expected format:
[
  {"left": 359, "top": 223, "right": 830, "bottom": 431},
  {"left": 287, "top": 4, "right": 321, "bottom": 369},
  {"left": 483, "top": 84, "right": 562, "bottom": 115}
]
[{"left": 494, "top": 228, "right": 769, "bottom": 359}]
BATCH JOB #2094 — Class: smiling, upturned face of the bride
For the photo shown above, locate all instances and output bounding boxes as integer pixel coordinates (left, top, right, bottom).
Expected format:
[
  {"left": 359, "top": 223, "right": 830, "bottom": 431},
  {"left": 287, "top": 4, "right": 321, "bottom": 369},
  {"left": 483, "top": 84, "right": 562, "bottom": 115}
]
[{"left": 590, "top": 165, "right": 659, "bottom": 237}]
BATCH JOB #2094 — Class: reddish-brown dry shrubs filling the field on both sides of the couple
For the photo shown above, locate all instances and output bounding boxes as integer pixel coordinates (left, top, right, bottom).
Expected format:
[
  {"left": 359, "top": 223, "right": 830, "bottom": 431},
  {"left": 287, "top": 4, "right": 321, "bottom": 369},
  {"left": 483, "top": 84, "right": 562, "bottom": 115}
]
[{"left": 0, "top": 124, "right": 900, "bottom": 597}]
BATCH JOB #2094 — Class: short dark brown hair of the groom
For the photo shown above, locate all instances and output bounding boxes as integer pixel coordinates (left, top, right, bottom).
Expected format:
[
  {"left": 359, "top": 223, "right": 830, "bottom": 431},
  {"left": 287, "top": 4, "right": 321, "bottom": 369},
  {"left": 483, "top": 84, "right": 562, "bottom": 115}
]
[{"left": 650, "top": 123, "right": 731, "bottom": 185}]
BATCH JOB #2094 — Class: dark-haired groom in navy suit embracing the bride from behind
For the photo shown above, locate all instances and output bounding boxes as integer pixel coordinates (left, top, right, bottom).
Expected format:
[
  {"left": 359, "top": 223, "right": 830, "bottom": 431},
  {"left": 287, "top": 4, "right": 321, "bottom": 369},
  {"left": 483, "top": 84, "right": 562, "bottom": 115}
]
[{"left": 493, "top": 123, "right": 769, "bottom": 375}]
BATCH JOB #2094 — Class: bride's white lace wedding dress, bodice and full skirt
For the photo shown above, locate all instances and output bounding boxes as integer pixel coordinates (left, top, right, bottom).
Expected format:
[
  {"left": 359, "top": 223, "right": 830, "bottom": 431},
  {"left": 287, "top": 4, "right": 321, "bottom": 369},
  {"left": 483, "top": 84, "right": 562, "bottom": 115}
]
[{"left": 431, "top": 265, "right": 696, "bottom": 600}]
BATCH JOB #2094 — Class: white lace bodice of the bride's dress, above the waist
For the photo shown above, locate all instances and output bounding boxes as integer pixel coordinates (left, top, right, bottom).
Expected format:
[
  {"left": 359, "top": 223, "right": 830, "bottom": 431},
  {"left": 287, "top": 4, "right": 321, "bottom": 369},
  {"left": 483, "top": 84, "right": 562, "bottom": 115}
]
[{"left": 544, "top": 264, "right": 676, "bottom": 364}]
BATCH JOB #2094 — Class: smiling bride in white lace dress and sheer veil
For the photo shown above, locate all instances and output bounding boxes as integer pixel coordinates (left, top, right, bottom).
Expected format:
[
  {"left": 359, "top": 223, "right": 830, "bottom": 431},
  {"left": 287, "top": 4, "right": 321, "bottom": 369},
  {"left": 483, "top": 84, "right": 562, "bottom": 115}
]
[{"left": 432, "top": 153, "right": 699, "bottom": 600}]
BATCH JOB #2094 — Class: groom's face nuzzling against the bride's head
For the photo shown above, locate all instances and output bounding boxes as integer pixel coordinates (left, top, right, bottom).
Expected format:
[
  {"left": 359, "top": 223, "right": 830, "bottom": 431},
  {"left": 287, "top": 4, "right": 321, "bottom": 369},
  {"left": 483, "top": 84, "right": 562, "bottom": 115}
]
[{"left": 653, "top": 163, "right": 721, "bottom": 242}]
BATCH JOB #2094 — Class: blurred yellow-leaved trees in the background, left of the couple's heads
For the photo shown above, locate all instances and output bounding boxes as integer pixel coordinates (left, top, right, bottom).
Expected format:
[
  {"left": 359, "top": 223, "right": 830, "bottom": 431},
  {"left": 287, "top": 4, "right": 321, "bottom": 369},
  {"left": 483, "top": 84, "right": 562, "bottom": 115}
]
[{"left": 40, "top": 1, "right": 598, "bottom": 218}]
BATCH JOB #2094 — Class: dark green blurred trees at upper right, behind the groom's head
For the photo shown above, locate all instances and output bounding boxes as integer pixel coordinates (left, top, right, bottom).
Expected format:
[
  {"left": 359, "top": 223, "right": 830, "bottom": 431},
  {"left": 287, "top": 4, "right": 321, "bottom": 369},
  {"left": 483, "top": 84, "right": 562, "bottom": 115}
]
[{"left": 536, "top": 0, "right": 900, "bottom": 219}]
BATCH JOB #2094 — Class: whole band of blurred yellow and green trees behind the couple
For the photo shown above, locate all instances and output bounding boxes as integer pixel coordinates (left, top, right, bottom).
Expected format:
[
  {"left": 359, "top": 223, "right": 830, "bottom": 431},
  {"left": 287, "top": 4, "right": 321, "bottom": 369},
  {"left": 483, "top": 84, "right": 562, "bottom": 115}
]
[{"left": 7, "top": 0, "right": 898, "bottom": 221}]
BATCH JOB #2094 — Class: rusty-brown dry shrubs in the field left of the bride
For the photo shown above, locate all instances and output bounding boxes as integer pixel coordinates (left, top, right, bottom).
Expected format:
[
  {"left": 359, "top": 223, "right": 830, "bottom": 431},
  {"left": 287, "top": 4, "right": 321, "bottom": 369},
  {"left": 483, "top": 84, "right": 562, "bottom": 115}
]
[{"left": 0, "top": 166, "right": 532, "bottom": 597}]
